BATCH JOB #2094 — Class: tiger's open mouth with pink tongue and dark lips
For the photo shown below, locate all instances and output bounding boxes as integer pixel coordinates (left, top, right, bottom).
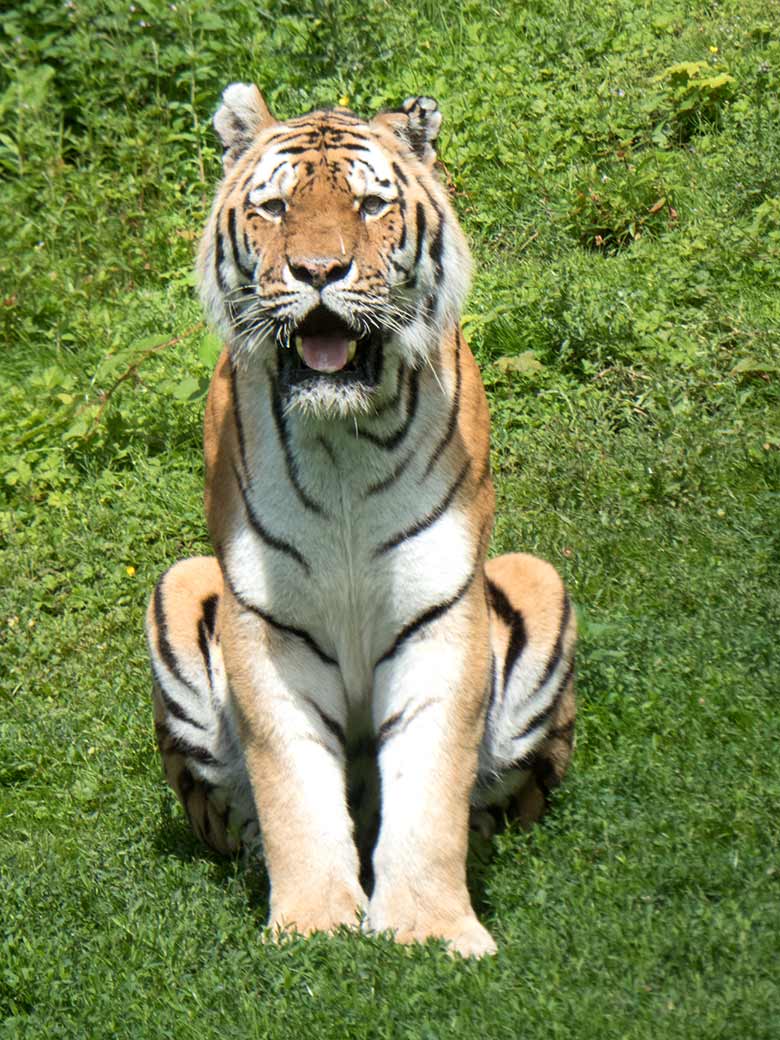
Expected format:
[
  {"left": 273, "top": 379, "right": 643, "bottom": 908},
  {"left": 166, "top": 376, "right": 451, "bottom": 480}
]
[{"left": 280, "top": 305, "right": 382, "bottom": 386}]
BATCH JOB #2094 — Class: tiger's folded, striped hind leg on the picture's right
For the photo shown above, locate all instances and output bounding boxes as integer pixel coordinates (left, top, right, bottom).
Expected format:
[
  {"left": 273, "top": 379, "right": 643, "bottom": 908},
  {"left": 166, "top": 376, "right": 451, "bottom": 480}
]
[{"left": 472, "top": 553, "right": 576, "bottom": 833}]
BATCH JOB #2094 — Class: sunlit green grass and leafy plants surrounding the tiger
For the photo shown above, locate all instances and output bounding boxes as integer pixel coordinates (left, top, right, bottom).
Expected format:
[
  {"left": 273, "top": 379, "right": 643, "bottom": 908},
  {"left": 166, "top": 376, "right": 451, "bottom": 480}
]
[{"left": 0, "top": 0, "right": 780, "bottom": 1040}]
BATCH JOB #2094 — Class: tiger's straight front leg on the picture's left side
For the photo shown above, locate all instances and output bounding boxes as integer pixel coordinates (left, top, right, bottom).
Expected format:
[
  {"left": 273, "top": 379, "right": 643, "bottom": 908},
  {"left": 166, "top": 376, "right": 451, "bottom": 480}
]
[{"left": 218, "top": 592, "right": 366, "bottom": 935}]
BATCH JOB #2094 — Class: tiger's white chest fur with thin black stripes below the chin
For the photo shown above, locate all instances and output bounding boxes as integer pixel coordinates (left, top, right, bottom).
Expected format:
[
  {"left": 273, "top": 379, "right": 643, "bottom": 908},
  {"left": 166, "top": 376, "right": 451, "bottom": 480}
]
[{"left": 224, "top": 351, "right": 474, "bottom": 703}]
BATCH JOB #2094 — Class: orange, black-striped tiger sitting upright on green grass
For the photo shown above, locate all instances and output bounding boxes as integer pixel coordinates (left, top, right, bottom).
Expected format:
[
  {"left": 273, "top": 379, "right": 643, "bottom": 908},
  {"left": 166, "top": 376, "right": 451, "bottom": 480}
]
[{"left": 148, "top": 83, "right": 575, "bottom": 957}]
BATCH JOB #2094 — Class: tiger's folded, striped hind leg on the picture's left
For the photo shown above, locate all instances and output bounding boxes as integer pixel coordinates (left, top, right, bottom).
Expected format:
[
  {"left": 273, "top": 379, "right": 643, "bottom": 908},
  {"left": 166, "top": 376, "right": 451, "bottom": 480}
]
[{"left": 147, "top": 556, "right": 259, "bottom": 855}]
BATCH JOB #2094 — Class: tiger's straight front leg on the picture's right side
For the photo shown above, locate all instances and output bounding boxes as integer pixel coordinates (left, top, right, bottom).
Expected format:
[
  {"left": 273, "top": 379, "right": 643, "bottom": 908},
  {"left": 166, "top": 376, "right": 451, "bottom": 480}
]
[{"left": 368, "top": 609, "right": 495, "bottom": 957}]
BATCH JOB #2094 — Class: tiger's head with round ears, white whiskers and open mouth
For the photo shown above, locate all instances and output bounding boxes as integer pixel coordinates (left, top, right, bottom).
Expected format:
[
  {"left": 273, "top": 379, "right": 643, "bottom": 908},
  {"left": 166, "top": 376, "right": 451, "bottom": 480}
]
[{"left": 198, "top": 83, "right": 470, "bottom": 417}]
